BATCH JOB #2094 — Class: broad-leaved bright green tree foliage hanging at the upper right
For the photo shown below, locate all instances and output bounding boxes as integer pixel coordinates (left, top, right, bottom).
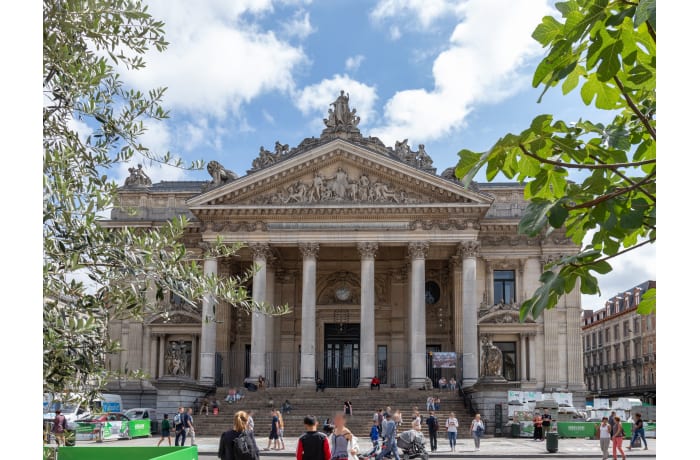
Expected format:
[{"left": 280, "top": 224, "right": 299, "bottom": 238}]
[{"left": 457, "top": 0, "right": 656, "bottom": 318}]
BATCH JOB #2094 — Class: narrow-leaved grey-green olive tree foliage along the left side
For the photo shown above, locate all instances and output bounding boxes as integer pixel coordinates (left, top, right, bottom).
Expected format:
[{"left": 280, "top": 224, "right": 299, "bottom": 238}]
[{"left": 43, "top": 0, "right": 286, "bottom": 392}]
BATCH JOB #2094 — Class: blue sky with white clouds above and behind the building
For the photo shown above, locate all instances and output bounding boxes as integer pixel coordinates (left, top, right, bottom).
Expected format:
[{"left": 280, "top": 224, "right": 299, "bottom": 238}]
[{"left": 78, "top": 0, "right": 656, "bottom": 308}]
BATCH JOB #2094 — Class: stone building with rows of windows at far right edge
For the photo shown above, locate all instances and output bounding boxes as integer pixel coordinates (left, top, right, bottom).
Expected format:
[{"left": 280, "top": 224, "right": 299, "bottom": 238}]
[{"left": 582, "top": 281, "right": 656, "bottom": 404}]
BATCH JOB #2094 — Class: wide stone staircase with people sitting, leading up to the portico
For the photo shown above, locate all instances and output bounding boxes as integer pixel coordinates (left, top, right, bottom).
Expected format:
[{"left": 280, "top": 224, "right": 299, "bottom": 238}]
[{"left": 194, "top": 388, "right": 471, "bottom": 443}]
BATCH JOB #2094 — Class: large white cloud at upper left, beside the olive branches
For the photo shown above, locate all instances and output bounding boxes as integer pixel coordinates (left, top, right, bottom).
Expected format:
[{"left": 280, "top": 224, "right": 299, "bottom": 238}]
[{"left": 118, "top": 0, "right": 306, "bottom": 118}]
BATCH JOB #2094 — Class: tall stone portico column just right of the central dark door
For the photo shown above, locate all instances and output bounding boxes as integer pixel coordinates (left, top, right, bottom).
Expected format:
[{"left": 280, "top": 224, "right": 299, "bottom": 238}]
[{"left": 357, "top": 243, "right": 379, "bottom": 388}]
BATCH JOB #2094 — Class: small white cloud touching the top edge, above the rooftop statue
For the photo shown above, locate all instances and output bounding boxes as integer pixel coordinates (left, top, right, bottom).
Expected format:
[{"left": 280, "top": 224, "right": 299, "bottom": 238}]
[{"left": 370, "top": 0, "right": 460, "bottom": 30}]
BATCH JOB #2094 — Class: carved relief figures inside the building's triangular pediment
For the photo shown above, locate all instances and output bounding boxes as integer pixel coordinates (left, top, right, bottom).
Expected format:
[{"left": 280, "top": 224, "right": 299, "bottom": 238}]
[{"left": 262, "top": 168, "right": 410, "bottom": 204}]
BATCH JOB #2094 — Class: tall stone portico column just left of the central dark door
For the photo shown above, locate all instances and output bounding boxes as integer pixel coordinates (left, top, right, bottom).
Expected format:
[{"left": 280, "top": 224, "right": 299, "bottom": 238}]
[{"left": 299, "top": 243, "right": 319, "bottom": 388}]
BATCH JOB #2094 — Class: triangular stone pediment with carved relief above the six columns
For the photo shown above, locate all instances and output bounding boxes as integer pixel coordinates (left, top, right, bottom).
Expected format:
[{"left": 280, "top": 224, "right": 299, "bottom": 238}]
[{"left": 188, "top": 139, "right": 493, "bottom": 208}]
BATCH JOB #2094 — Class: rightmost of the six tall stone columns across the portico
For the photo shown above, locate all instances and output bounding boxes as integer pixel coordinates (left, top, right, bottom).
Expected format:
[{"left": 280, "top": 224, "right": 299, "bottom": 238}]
[{"left": 458, "top": 241, "right": 479, "bottom": 387}]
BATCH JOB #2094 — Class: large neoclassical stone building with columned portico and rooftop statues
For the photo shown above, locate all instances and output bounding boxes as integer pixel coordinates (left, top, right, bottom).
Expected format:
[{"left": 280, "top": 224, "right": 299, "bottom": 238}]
[{"left": 104, "top": 92, "right": 585, "bottom": 404}]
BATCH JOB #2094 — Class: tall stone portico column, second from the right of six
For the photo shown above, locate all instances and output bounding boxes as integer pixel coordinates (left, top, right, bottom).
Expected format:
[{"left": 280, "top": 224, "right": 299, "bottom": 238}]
[{"left": 408, "top": 242, "right": 428, "bottom": 388}]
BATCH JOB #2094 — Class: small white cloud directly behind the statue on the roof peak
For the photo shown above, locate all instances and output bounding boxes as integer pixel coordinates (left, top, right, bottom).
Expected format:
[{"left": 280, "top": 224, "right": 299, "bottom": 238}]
[{"left": 295, "top": 74, "right": 377, "bottom": 123}]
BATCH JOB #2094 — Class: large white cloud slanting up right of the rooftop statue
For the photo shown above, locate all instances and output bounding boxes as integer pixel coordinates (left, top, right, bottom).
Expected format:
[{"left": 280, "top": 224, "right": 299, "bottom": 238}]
[{"left": 372, "top": 0, "right": 551, "bottom": 144}]
